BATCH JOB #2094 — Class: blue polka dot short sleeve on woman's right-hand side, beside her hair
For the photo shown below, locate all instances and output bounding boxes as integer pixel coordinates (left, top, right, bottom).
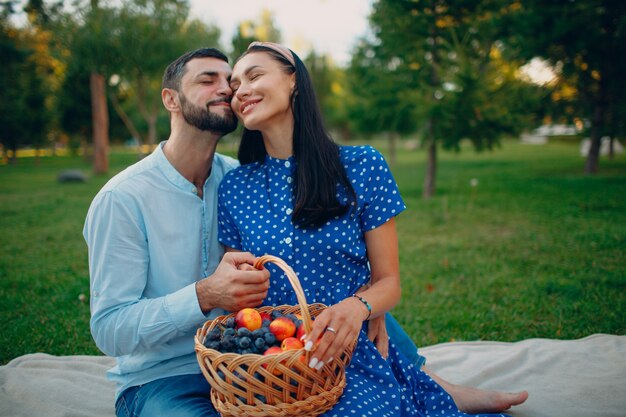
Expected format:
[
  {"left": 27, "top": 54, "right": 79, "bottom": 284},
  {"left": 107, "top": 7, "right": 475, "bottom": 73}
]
[{"left": 357, "top": 146, "right": 406, "bottom": 231}]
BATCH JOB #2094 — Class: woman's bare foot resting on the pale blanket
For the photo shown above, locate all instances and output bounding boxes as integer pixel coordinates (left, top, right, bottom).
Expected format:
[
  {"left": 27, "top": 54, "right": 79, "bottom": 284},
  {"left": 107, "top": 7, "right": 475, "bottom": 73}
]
[{"left": 422, "top": 367, "right": 528, "bottom": 414}]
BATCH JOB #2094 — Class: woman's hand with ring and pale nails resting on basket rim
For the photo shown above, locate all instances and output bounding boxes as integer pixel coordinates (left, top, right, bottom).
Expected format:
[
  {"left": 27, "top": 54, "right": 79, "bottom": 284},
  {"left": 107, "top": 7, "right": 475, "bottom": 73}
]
[{"left": 304, "top": 297, "right": 369, "bottom": 370}]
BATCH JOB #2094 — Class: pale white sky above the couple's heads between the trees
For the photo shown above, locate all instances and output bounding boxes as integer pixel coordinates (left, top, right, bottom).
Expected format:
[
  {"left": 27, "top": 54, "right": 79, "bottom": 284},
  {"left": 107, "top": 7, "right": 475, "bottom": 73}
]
[{"left": 190, "top": 0, "right": 372, "bottom": 66}]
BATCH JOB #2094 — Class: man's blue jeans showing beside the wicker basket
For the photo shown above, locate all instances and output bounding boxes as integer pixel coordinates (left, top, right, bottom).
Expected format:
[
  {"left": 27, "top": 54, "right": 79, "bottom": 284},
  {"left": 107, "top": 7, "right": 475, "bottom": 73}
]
[{"left": 115, "top": 374, "right": 218, "bottom": 417}]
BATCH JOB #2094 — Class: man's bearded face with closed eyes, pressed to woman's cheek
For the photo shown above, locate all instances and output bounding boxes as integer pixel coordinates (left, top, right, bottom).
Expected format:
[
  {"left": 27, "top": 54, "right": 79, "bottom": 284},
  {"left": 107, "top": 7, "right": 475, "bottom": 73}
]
[{"left": 179, "top": 58, "right": 237, "bottom": 134}]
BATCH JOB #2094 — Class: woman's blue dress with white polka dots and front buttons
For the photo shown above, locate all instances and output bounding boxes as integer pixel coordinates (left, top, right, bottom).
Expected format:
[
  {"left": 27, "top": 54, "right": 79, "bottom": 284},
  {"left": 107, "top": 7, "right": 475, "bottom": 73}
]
[{"left": 218, "top": 146, "right": 502, "bottom": 417}]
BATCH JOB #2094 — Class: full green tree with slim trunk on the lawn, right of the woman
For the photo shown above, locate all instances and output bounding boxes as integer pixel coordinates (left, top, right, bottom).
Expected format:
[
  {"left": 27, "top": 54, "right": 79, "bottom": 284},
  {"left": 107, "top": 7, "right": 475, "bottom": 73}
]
[{"left": 367, "top": 0, "right": 536, "bottom": 198}]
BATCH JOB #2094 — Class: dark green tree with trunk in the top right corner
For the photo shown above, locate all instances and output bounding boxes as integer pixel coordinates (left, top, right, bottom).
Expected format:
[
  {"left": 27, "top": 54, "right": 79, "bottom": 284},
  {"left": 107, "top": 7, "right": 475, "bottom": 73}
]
[{"left": 507, "top": 0, "right": 626, "bottom": 174}]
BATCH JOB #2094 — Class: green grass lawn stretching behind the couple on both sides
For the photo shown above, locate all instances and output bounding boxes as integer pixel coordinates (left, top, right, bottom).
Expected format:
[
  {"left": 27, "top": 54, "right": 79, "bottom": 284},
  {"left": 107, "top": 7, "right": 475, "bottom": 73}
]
[{"left": 0, "top": 142, "right": 626, "bottom": 363}]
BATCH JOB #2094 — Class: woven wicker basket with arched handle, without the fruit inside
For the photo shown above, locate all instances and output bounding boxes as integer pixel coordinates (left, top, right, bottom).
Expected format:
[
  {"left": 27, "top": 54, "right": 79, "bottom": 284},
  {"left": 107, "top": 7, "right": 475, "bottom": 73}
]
[{"left": 194, "top": 255, "right": 356, "bottom": 417}]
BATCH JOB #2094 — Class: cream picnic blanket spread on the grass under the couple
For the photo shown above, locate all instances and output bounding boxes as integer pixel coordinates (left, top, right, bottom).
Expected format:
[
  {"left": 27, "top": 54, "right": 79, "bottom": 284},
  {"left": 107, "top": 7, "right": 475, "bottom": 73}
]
[{"left": 0, "top": 334, "right": 626, "bottom": 417}]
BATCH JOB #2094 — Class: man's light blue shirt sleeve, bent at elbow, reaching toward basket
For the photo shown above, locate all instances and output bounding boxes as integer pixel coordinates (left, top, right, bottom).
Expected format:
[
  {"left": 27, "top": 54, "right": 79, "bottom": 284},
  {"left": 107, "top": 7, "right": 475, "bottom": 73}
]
[{"left": 83, "top": 191, "right": 206, "bottom": 356}]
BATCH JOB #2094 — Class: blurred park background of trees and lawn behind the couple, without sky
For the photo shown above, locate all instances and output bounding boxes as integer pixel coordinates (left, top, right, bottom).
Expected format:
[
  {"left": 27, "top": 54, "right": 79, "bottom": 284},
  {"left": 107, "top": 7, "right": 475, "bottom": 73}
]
[{"left": 0, "top": 0, "right": 626, "bottom": 364}]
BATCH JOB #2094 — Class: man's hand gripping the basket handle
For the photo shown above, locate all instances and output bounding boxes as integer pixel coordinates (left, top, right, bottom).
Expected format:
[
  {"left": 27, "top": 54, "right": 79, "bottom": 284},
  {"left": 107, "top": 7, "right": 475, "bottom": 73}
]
[{"left": 196, "top": 252, "right": 270, "bottom": 314}]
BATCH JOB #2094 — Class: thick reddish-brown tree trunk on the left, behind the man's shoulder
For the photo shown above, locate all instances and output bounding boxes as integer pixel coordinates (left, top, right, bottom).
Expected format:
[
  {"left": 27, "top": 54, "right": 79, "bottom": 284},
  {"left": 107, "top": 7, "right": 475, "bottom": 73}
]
[{"left": 89, "top": 72, "right": 109, "bottom": 174}]
